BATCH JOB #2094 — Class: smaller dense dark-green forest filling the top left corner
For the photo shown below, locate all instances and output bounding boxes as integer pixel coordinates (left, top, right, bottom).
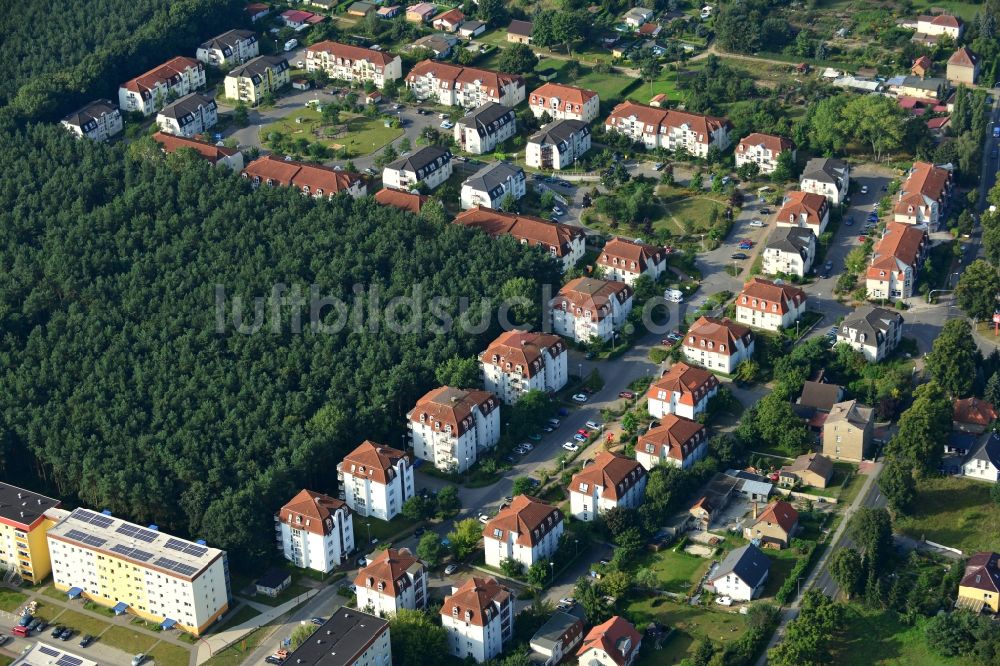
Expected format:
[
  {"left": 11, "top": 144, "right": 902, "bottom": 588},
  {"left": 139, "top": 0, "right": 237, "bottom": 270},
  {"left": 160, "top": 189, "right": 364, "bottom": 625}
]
[{"left": 0, "top": 0, "right": 246, "bottom": 120}]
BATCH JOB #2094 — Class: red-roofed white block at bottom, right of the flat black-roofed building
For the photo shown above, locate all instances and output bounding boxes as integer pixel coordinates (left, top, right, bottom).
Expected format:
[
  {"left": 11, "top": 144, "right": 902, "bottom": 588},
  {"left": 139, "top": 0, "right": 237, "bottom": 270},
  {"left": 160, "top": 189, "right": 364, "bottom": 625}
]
[{"left": 441, "top": 576, "right": 514, "bottom": 664}]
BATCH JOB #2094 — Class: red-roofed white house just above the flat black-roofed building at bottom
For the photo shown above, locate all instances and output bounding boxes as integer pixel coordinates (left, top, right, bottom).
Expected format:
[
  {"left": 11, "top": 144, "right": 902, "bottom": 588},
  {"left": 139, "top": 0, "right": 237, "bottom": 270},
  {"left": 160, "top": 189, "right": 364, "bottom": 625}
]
[{"left": 354, "top": 548, "right": 427, "bottom": 617}]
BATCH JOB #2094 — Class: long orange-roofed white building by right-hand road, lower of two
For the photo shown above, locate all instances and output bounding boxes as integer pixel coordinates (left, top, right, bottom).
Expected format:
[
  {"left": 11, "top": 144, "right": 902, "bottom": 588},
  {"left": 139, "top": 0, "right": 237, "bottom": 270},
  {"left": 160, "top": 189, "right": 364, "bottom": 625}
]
[{"left": 865, "top": 222, "right": 929, "bottom": 300}]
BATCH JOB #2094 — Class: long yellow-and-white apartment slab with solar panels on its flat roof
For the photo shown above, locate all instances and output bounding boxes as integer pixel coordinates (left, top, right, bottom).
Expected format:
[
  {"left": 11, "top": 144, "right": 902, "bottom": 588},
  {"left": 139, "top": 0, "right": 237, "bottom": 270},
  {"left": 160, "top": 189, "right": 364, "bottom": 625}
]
[{"left": 48, "top": 509, "right": 232, "bottom": 636}]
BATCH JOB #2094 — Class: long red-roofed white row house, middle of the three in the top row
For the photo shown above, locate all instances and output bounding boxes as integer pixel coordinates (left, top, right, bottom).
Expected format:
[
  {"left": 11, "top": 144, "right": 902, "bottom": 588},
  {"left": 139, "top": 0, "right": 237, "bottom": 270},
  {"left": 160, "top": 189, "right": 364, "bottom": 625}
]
[{"left": 406, "top": 60, "right": 525, "bottom": 109}]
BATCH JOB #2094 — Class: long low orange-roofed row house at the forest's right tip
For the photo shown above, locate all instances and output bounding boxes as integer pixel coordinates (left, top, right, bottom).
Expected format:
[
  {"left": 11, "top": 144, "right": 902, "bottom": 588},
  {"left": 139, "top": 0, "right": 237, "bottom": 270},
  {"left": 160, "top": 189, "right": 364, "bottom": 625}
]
[{"left": 454, "top": 206, "right": 586, "bottom": 273}]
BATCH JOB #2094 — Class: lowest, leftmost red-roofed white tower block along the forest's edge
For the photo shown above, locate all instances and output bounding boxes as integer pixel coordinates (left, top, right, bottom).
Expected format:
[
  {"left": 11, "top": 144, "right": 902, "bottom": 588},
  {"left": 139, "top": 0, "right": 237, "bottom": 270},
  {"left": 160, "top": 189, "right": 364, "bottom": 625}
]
[{"left": 274, "top": 490, "right": 354, "bottom": 573}]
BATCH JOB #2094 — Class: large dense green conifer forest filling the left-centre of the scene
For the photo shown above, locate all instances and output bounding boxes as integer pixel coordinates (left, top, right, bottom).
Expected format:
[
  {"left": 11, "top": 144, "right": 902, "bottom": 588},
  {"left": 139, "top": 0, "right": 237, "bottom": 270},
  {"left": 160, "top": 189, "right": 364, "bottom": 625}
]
[{"left": 0, "top": 126, "right": 559, "bottom": 562}]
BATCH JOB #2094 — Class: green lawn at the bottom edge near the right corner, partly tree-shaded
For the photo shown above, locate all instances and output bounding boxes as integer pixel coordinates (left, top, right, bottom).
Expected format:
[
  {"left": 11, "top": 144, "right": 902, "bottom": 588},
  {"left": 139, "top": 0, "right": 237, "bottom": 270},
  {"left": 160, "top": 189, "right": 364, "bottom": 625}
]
[{"left": 831, "top": 604, "right": 973, "bottom": 666}]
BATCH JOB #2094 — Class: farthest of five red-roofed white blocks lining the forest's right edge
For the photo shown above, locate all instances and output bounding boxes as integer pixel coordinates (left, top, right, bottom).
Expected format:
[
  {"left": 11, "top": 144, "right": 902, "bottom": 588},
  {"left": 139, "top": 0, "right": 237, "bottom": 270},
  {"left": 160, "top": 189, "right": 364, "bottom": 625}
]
[{"left": 549, "top": 278, "right": 633, "bottom": 343}]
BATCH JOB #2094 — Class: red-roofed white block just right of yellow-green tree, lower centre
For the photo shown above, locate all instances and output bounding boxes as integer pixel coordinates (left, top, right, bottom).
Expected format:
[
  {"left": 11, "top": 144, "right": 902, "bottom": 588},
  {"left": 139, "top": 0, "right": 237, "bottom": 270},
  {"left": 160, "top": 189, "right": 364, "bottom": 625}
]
[{"left": 483, "top": 495, "right": 565, "bottom": 570}]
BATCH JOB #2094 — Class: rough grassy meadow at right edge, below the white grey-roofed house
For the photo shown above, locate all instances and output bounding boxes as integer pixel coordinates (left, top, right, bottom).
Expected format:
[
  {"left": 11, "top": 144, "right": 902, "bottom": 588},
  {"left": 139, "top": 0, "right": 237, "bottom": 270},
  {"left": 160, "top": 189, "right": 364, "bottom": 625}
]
[{"left": 896, "top": 477, "right": 1000, "bottom": 555}]
